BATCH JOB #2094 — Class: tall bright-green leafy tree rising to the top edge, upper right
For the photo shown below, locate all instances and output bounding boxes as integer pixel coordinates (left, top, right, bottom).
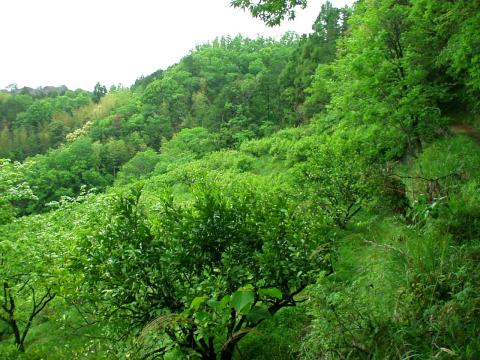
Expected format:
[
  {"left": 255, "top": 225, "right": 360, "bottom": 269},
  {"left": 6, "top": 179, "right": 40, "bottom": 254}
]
[{"left": 318, "top": 0, "right": 447, "bottom": 153}]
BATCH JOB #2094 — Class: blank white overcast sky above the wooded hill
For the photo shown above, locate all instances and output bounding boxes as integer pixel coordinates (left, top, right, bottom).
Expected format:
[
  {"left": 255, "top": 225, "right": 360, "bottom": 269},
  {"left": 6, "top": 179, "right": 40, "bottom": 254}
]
[{"left": 0, "top": 0, "right": 353, "bottom": 90}]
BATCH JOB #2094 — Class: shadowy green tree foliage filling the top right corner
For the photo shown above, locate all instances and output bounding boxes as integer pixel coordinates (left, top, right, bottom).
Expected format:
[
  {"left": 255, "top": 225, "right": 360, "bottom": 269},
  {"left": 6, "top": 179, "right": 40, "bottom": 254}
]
[{"left": 410, "top": 0, "right": 480, "bottom": 111}]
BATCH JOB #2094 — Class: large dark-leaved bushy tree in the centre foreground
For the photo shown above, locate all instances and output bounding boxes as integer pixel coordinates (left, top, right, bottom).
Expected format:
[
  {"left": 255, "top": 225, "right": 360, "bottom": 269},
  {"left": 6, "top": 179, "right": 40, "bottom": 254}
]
[{"left": 79, "top": 182, "right": 330, "bottom": 359}]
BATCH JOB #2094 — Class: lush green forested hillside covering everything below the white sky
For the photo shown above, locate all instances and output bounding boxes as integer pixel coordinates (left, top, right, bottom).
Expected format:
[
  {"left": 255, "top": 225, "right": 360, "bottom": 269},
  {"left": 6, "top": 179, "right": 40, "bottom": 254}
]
[{"left": 0, "top": 0, "right": 480, "bottom": 360}]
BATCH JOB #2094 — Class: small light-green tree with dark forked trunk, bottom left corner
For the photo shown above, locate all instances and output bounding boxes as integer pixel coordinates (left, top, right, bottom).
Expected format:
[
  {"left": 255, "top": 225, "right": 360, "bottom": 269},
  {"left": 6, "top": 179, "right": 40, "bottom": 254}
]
[{"left": 0, "top": 197, "right": 92, "bottom": 351}]
